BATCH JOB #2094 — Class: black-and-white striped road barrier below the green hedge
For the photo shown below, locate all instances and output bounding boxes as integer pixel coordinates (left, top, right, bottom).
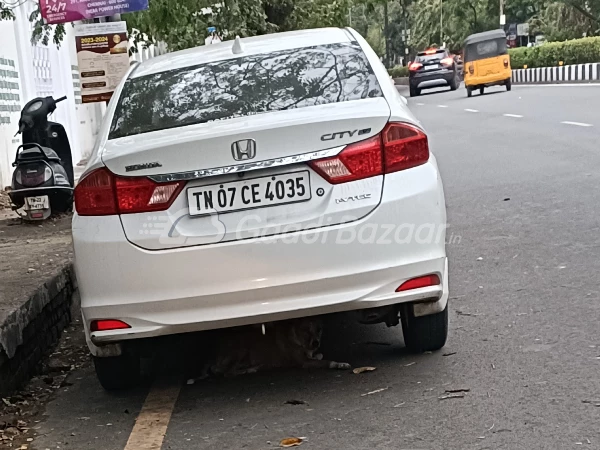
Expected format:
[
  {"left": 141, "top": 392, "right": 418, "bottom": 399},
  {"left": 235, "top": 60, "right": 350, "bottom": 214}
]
[{"left": 512, "top": 63, "right": 600, "bottom": 84}]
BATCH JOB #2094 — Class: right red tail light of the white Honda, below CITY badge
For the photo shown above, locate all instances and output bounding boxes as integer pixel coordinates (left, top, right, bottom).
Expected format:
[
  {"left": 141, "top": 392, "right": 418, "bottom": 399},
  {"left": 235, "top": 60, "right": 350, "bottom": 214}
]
[{"left": 310, "top": 122, "right": 429, "bottom": 184}]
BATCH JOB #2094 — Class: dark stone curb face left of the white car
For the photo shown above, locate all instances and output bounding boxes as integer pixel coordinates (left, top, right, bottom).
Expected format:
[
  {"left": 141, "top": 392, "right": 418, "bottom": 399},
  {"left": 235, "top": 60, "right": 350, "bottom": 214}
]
[{"left": 0, "top": 264, "right": 77, "bottom": 396}]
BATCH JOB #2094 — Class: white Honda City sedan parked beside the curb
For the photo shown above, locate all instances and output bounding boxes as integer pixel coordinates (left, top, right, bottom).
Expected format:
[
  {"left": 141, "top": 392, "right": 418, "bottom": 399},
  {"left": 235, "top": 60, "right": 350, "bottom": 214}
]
[{"left": 73, "top": 29, "right": 448, "bottom": 389}]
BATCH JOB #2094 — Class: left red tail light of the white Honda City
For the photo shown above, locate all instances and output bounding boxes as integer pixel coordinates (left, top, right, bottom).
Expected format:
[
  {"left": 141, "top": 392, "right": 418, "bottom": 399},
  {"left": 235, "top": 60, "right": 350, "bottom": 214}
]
[{"left": 75, "top": 168, "right": 184, "bottom": 216}]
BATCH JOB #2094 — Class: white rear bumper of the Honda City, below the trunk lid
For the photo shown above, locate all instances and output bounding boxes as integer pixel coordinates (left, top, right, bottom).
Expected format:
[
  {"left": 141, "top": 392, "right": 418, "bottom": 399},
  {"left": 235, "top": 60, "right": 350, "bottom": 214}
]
[{"left": 73, "top": 157, "right": 448, "bottom": 351}]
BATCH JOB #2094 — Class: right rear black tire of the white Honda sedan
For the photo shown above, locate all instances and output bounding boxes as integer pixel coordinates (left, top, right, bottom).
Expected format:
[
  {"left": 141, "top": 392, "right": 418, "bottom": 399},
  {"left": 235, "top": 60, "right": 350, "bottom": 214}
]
[{"left": 400, "top": 304, "right": 448, "bottom": 353}]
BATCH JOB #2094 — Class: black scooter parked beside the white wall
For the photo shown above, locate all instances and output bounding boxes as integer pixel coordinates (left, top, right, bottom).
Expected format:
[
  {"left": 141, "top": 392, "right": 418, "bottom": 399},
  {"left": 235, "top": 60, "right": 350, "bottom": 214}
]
[{"left": 8, "top": 97, "right": 75, "bottom": 220}]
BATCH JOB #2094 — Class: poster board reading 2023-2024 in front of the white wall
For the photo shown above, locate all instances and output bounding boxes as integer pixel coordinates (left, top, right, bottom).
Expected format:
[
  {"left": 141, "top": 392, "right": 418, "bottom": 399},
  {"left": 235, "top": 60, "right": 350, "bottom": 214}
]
[{"left": 75, "top": 22, "right": 129, "bottom": 103}]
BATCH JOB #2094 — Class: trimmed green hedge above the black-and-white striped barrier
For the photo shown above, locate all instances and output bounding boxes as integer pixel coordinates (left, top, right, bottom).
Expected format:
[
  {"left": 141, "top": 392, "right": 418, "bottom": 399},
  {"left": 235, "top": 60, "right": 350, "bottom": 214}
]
[{"left": 509, "top": 37, "right": 600, "bottom": 69}]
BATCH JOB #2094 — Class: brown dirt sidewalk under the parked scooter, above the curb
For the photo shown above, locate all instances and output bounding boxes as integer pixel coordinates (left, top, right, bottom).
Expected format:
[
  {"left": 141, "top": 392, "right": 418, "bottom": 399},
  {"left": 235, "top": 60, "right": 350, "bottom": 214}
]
[{"left": 0, "top": 210, "right": 73, "bottom": 322}]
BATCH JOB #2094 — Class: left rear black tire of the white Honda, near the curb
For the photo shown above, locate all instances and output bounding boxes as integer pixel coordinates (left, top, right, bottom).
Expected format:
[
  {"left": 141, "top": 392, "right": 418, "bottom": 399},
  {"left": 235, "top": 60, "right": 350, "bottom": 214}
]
[{"left": 93, "top": 354, "right": 140, "bottom": 391}]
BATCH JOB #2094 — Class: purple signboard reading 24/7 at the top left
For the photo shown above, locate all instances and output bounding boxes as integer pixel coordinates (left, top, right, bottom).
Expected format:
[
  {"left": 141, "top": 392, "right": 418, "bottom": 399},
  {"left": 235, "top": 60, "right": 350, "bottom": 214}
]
[{"left": 40, "top": 0, "right": 148, "bottom": 24}]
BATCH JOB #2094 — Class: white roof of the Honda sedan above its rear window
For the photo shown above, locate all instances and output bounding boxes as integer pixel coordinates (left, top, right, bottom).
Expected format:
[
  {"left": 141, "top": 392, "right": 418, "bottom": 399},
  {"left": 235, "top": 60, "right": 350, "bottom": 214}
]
[{"left": 131, "top": 28, "right": 354, "bottom": 78}]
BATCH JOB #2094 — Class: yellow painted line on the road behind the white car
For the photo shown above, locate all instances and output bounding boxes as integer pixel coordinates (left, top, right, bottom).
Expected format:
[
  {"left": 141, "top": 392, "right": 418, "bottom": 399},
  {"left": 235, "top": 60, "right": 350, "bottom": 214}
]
[{"left": 125, "top": 379, "right": 181, "bottom": 450}]
